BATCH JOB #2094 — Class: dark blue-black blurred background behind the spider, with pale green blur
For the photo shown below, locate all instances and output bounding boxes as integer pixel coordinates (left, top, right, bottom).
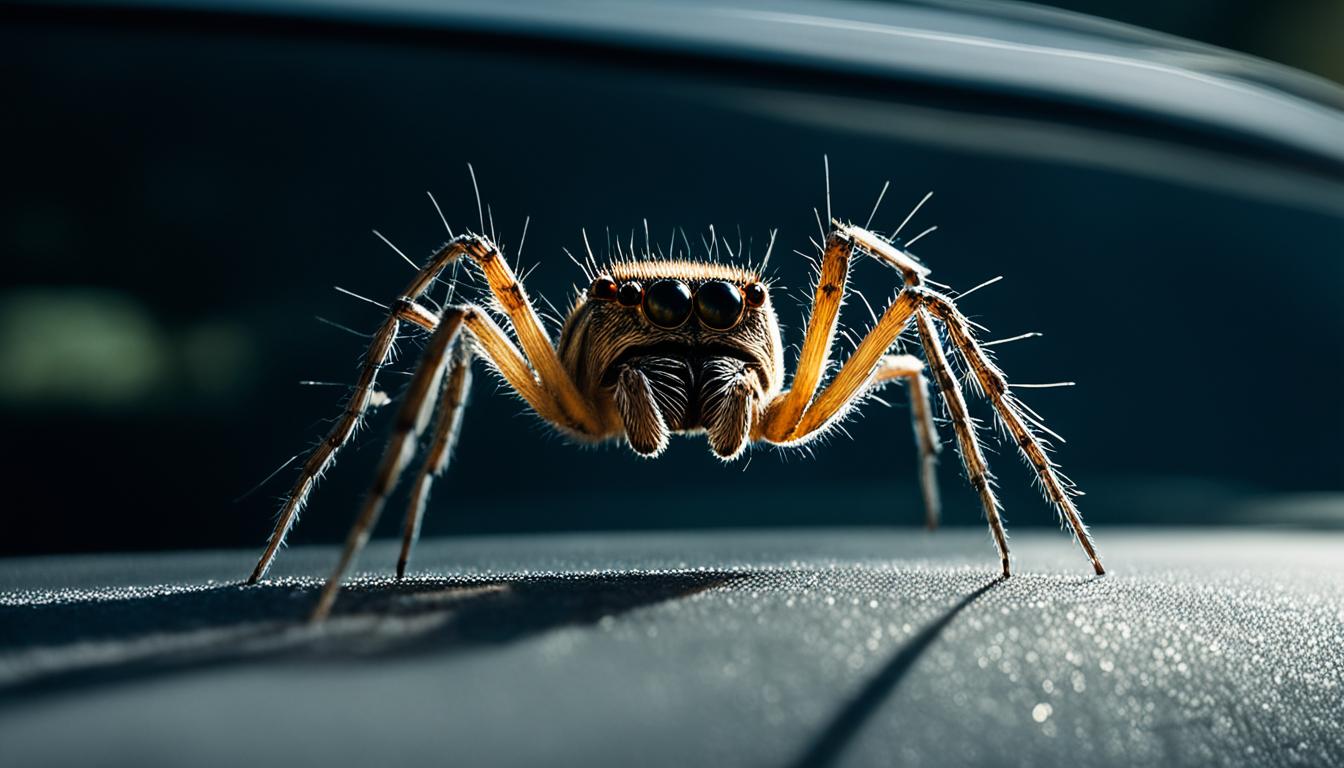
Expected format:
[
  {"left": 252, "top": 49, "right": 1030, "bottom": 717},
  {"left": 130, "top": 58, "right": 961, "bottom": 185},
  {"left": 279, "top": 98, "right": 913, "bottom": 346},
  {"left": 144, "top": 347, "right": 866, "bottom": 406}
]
[{"left": 0, "top": 3, "right": 1344, "bottom": 554}]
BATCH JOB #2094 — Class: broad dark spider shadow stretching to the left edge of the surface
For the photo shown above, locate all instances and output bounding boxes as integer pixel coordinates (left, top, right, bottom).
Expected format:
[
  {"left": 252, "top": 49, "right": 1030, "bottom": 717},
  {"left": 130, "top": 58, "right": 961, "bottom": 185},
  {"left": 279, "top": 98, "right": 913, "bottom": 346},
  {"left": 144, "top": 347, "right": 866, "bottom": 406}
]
[{"left": 0, "top": 572, "right": 749, "bottom": 710}]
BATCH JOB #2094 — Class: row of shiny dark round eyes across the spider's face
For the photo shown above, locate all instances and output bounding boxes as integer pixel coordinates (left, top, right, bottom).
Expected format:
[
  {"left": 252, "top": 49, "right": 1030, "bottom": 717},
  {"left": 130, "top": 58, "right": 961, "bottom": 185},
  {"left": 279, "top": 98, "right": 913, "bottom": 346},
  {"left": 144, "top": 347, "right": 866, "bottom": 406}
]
[{"left": 589, "top": 277, "right": 765, "bottom": 331}]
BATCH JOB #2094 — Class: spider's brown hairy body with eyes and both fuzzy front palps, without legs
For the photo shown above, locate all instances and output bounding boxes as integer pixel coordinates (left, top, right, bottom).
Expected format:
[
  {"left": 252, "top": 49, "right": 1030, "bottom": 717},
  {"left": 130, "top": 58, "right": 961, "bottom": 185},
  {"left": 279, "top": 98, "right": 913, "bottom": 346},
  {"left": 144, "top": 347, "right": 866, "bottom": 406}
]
[{"left": 559, "top": 261, "right": 784, "bottom": 459}]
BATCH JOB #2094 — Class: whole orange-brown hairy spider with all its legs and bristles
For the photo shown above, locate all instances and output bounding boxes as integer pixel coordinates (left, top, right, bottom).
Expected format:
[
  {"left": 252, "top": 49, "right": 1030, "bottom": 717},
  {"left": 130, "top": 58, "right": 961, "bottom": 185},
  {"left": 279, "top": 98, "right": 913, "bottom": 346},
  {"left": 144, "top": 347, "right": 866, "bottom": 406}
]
[{"left": 249, "top": 165, "right": 1103, "bottom": 620}]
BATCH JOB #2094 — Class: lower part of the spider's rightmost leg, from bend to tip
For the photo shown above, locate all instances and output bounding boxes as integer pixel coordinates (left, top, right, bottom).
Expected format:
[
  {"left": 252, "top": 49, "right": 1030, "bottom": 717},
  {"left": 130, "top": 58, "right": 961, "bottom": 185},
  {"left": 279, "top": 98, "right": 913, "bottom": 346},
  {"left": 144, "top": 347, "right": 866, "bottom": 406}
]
[{"left": 927, "top": 293, "right": 1106, "bottom": 576}]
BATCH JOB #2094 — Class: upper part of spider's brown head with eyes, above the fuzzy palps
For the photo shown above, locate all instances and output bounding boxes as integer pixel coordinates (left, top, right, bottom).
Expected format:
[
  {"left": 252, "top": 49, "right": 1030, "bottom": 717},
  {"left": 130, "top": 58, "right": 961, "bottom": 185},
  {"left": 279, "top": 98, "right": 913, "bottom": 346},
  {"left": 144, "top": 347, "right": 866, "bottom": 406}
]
[{"left": 560, "top": 261, "right": 784, "bottom": 406}]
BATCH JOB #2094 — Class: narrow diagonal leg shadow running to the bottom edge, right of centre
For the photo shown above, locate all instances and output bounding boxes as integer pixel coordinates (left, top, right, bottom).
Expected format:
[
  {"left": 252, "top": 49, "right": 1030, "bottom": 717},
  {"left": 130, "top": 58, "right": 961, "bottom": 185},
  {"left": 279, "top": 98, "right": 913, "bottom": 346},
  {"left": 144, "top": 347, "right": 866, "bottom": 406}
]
[{"left": 789, "top": 577, "right": 1004, "bottom": 768}]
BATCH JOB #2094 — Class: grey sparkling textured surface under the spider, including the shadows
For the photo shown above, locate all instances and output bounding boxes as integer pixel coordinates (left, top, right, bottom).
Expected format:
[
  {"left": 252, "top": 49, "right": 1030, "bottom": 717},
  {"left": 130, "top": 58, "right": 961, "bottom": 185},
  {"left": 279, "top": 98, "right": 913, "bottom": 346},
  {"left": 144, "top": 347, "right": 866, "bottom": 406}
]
[{"left": 0, "top": 530, "right": 1344, "bottom": 765}]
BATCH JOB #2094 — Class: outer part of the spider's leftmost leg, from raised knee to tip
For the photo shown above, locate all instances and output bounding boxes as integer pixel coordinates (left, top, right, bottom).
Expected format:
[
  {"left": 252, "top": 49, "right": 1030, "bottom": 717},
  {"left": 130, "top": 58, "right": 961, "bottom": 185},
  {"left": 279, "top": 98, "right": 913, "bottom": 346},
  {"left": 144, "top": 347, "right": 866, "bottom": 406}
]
[{"left": 247, "top": 237, "right": 477, "bottom": 584}]
